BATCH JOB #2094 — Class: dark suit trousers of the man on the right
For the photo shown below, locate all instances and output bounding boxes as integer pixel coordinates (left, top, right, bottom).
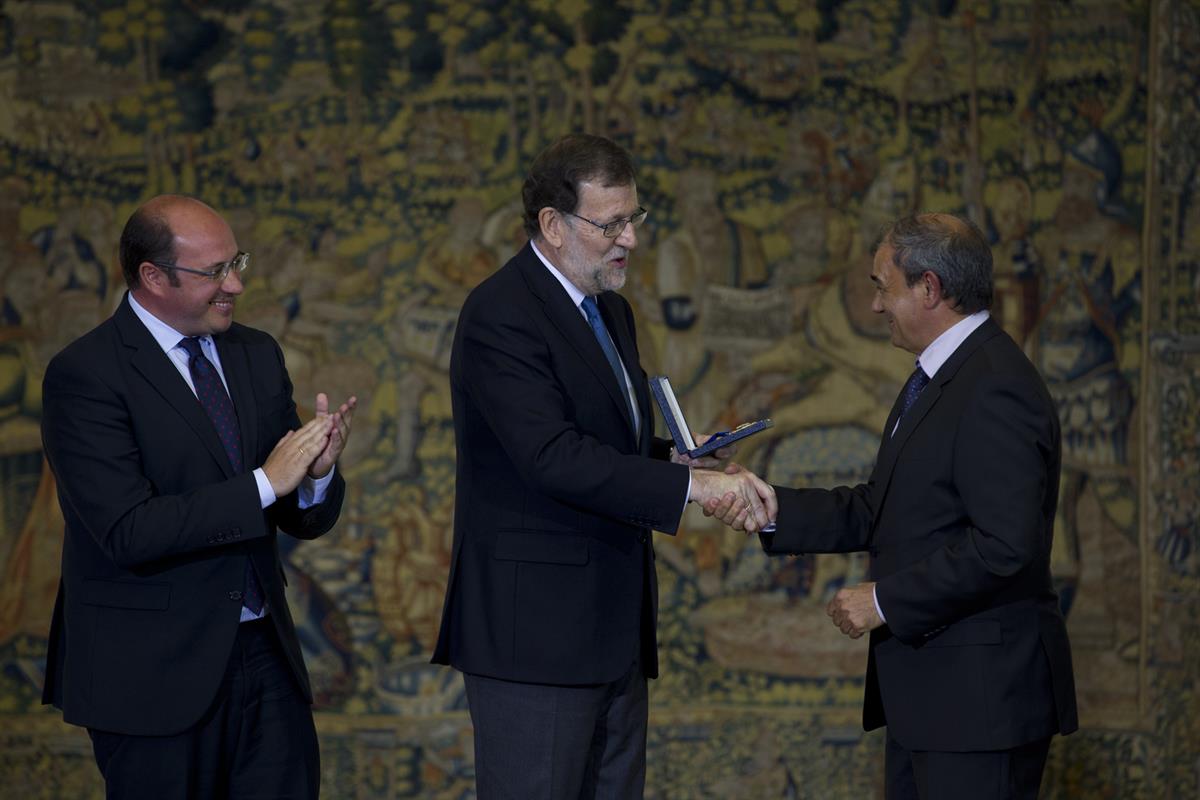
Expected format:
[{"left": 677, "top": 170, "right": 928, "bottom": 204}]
[{"left": 883, "top": 734, "right": 1050, "bottom": 800}]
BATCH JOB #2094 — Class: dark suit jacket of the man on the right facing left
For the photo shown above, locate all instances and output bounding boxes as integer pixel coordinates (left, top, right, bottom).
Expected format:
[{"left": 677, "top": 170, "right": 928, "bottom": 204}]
[{"left": 762, "top": 319, "right": 1078, "bottom": 751}]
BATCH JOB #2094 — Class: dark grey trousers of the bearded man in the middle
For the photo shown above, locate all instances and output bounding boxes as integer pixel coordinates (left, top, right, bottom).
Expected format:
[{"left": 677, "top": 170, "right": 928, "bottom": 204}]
[{"left": 463, "top": 661, "right": 649, "bottom": 800}]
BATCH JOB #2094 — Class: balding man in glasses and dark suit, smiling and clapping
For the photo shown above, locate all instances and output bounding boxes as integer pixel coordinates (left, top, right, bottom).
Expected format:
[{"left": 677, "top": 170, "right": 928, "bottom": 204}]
[{"left": 42, "top": 196, "right": 355, "bottom": 800}]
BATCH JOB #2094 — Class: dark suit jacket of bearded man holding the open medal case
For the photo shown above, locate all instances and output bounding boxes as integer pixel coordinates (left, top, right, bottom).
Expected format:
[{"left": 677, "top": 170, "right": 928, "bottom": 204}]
[{"left": 433, "top": 245, "right": 688, "bottom": 685}]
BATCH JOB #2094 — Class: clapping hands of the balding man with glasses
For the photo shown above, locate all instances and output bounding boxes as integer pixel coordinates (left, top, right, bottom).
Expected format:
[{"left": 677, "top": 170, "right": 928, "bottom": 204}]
[{"left": 263, "top": 392, "right": 359, "bottom": 497}]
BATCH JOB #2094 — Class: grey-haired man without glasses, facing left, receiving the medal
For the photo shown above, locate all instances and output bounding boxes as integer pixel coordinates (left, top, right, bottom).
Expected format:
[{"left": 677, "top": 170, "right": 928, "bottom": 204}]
[{"left": 706, "top": 215, "right": 1078, "bottom": 800}]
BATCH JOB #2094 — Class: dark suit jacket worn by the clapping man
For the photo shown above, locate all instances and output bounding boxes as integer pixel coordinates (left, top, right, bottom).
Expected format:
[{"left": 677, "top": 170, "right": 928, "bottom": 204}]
[{"left": 42, "top": 297, "right": 344, "bottom": 735}]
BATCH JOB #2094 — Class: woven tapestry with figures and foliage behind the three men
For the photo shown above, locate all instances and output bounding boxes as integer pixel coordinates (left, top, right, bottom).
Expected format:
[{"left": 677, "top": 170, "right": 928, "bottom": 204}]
[{"left": 0, "top": 0, "right": 1200, "bottom": 800}]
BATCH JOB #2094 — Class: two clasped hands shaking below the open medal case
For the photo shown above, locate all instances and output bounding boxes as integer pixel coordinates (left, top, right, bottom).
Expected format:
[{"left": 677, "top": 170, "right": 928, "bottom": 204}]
[{"left": 671, "top": 435, "right": 779, "bottom": 534}]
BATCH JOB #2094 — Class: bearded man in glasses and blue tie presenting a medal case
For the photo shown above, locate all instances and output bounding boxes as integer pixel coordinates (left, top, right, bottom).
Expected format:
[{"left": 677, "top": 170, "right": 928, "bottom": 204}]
[{"left": 433, "top": 134, "right": 774, "bottom": 800}]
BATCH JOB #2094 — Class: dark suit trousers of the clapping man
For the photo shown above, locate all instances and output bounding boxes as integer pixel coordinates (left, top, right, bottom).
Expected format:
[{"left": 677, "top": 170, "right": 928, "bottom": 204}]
[{"left": 88, "top": 616, "right": 320, "bottom": 800}]
